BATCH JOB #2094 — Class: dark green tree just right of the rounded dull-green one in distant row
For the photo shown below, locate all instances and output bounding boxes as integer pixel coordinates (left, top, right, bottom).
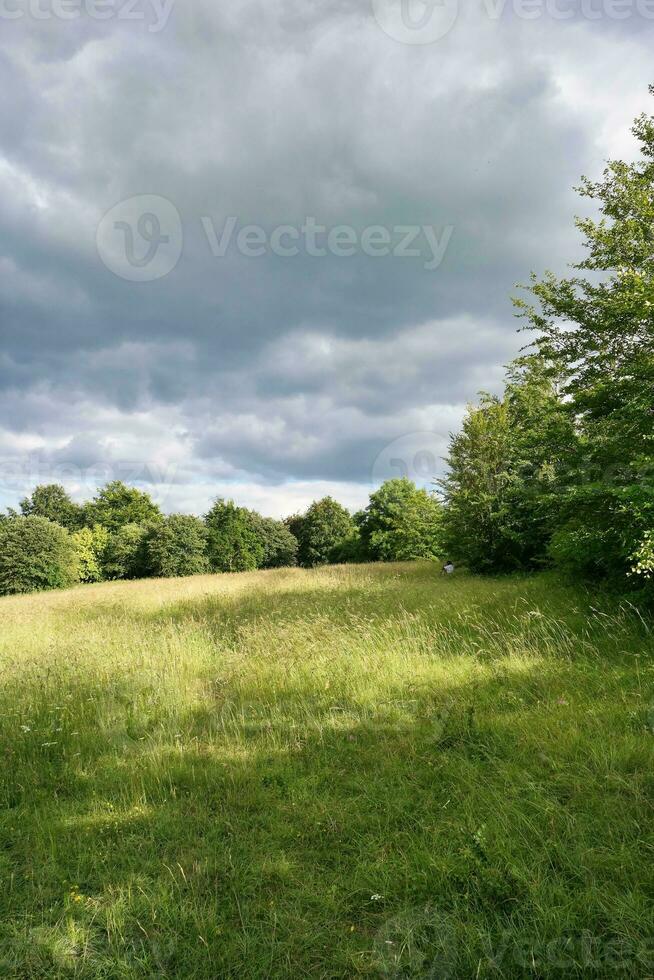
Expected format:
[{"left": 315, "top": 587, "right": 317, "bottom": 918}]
[{"left": 204, "top": 497, "right": 265, "bottom": 572}]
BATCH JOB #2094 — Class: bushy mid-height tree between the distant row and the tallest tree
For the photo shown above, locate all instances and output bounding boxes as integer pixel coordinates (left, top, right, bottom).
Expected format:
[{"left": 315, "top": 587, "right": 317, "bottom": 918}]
[{"left": 440, "top": 355, "right": 578, "bottom": 572}]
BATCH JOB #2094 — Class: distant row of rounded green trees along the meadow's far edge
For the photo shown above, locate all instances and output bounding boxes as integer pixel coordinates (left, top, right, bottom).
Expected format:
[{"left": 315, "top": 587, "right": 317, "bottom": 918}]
[{"left": 0, "top": 479, "right": 442, "bottom": 595}]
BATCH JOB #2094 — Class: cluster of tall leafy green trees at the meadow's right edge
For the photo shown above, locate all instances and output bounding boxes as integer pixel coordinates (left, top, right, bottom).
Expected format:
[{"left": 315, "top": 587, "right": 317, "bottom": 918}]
[{"left": 441, "top": 87, "right": 654, "bottom": 599}]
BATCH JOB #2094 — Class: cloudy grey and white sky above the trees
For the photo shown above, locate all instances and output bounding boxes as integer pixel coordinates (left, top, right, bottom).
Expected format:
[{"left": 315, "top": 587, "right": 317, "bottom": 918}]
[{"left": 0, "top": 0, "right": 654, "bottom": 516}]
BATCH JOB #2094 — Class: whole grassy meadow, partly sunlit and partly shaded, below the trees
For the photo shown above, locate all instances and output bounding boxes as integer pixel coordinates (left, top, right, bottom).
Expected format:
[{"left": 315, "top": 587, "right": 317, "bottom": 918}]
[{"left": 0, "top": 563, "right": 654, "bottom": 980}]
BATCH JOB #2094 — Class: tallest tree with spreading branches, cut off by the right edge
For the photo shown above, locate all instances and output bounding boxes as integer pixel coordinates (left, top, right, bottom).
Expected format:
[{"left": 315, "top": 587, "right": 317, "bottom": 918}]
[{"left": 517, "top": 88, "right": 654, "bottom": 582}]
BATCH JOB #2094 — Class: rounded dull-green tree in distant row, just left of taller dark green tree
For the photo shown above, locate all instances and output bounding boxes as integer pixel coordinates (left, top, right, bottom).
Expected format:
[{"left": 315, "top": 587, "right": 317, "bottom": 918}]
[{"left": 145, "top": 514, "right": 209, "bottom": 578}]
